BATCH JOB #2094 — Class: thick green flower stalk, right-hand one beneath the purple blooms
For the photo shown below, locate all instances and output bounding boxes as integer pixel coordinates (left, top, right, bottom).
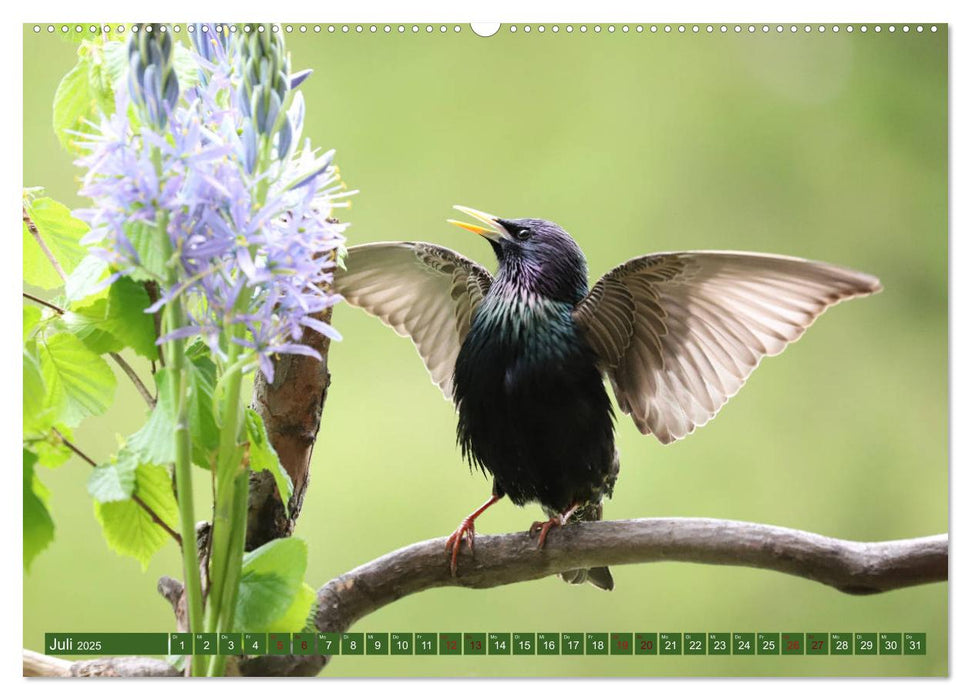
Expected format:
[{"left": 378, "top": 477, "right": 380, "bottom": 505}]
[{"left": 206, "top": 342, "right": 246, "bottom": 675}]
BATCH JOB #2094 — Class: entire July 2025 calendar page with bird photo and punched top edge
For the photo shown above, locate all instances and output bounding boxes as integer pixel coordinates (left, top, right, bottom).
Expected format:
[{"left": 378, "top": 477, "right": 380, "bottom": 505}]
[{"left": 22, "top": 21, "right": 950, "bottom": 678}]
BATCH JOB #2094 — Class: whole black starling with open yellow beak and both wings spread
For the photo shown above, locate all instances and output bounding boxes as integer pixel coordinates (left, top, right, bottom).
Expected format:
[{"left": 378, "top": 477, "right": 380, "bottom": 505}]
[{"left": 335, "top": 206, "right": 881, "bottom": 590}]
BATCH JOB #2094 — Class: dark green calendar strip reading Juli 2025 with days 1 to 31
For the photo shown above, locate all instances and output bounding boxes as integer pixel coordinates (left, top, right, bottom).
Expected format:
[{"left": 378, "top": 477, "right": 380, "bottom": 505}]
[{"left": 44, "top": 632, "right": 927, "bottom": 658}]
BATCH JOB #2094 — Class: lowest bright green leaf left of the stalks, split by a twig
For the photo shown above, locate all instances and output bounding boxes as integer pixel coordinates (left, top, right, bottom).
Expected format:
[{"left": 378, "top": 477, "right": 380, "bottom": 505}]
[{"left": 94, "top": 464, "right": 179, "bottom": 570}]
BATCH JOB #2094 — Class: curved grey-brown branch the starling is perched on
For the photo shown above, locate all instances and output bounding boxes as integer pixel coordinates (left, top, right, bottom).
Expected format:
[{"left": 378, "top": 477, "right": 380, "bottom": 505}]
[{"left": 24, "top": 518, "right": 948, "bottom": 676}]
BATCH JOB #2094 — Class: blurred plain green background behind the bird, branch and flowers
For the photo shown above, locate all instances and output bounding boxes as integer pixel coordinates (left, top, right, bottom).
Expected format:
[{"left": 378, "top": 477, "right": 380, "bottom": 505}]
[{"left": 23, "top": 25, "right": 948, "bottom": 676}]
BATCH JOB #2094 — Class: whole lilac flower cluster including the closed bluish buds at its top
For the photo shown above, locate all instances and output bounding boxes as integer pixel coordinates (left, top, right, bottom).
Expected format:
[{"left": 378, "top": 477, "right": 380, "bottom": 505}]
[{"left": 76, "top": 25, "right": 352, "bottom": 381}]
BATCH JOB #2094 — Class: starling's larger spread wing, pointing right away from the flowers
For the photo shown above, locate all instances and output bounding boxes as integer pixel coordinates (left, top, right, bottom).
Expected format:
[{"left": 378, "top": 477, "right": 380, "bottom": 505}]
[{"left": 574, "top": 251, "right": 881, "bottom": 443}]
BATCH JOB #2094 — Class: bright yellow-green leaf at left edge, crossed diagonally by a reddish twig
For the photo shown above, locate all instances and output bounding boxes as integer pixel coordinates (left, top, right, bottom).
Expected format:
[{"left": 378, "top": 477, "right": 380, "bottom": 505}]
[{"left": 23, "top": 197, "right": 88, "bottom": 289}]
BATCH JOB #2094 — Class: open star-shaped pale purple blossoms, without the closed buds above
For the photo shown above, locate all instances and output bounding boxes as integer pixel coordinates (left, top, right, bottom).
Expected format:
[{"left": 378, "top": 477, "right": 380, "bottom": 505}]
[{"left": 75, "top": 31, "right": 350, "bottom": 381}]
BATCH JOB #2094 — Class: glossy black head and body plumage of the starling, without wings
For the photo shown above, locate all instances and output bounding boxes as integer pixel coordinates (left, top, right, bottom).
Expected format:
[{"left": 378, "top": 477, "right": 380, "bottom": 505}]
[{"left": 454, "top": 219, "right": 617, "bottom": 515}]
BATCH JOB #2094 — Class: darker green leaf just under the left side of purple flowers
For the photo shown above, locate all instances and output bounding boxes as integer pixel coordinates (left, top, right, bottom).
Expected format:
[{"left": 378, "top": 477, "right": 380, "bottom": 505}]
[{"left": 64, "top": 277, "right": 158, "bottom": 360}]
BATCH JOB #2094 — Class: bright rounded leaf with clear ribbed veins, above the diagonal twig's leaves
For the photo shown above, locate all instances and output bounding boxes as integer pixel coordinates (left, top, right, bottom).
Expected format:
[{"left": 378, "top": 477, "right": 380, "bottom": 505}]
[{"left": 37, "top": 333, "right": 115, "bottom": 427}]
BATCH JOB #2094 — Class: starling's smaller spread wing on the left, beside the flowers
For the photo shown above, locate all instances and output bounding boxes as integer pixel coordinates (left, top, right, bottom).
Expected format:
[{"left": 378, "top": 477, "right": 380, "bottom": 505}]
[{"left": 334, "top": 242, "right": 492, "bottom": 399}]
